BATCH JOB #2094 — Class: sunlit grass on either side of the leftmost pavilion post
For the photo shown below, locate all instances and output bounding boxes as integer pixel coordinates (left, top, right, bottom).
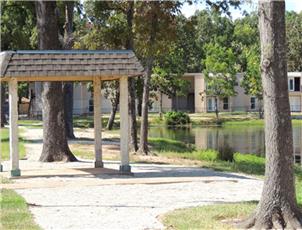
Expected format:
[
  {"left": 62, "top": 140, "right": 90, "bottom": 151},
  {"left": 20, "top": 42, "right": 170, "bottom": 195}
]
[{"left": 0, "top": 128, "right": 25, "bottom": 160}]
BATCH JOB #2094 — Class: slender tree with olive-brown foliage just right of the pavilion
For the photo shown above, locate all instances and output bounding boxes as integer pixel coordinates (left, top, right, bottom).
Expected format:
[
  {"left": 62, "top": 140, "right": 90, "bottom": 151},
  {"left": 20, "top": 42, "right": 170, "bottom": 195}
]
[{"left": 134, "top": 1, "right": 181, "bottom": 154}]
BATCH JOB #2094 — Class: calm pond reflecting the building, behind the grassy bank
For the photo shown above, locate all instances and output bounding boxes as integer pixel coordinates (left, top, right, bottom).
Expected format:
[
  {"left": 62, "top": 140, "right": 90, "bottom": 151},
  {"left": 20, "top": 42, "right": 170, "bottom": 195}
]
[{"left": 149, "top": 122, "right": 302, "bottom": 163}]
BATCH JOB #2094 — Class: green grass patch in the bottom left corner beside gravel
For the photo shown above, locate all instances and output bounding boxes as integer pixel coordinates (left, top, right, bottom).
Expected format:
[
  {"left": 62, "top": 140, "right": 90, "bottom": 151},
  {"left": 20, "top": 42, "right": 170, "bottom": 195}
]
[{"left": 0, "top": 189, "right": 40, "bottom": 230}]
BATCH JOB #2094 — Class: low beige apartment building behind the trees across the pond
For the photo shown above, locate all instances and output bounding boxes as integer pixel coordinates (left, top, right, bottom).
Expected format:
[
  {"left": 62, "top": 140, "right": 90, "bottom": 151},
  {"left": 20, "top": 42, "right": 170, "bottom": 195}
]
[{"left": 30, "top": 72, "right": 302, "bottom": 115}]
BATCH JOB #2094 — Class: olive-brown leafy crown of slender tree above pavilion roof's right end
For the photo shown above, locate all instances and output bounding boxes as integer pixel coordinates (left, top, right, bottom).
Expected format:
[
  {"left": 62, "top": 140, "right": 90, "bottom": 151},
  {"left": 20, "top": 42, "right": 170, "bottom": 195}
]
[{"left": 134, "top": 1, "right": 182, "bottom": 61}]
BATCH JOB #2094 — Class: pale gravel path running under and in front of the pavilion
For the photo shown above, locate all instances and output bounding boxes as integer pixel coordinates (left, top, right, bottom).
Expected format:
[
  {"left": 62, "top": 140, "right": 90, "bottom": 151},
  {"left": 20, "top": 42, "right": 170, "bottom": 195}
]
[{"left": 4, "top": 126, "right": 262, "bottom": 230}]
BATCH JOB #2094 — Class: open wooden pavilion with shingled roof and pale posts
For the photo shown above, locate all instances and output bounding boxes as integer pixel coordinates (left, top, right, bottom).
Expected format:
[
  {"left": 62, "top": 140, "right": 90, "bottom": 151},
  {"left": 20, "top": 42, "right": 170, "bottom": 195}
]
[{"left": 0, "top": 50, "right": 144, "bottom": 176}]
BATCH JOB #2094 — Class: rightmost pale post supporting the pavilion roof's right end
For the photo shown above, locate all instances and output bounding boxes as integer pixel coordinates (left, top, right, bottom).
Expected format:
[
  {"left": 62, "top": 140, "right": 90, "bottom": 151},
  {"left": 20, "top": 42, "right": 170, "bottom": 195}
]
[{"left": 120, "top": 77, "right": 131, "bottom": 173}]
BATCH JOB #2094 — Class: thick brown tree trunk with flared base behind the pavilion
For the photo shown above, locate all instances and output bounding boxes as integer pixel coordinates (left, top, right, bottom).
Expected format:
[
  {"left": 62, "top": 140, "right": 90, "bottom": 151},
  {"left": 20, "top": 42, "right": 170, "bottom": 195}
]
[{"left": 36, "top": 0, "right": 77, "bottom": 162}]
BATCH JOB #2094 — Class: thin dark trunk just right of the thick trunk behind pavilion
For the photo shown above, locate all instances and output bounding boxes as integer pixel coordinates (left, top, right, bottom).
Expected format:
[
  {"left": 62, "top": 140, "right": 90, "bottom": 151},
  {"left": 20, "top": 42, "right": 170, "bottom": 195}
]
[{"left": 63, "top": 1, "right": 75, "bottom": 139}]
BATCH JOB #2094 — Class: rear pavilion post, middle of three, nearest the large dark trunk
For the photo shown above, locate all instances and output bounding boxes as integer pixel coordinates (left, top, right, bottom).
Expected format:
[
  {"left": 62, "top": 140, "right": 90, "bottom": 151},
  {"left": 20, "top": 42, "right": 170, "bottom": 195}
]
[{"left": 93, "top": 77, "right": 103, "bottom": 168}]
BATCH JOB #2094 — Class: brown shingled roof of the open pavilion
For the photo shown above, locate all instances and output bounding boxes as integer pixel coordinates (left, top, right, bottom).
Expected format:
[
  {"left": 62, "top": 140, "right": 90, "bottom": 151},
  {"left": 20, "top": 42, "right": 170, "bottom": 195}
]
[{"left": 0, "top": 50, "right": 144, "bottom": 81}]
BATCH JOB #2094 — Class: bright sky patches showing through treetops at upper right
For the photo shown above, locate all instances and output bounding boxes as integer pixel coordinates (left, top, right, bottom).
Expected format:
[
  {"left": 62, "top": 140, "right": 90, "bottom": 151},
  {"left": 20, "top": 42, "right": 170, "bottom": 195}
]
[{"left": 182, "top": 0, "right": 302, "bottom": 19}]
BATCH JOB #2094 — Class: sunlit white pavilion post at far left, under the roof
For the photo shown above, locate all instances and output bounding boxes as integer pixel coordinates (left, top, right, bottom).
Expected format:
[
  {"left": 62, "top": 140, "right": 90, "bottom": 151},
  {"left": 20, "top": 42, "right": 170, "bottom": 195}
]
[{"left": 8, "top": 78, "right": 21, "bottom": 176}]
